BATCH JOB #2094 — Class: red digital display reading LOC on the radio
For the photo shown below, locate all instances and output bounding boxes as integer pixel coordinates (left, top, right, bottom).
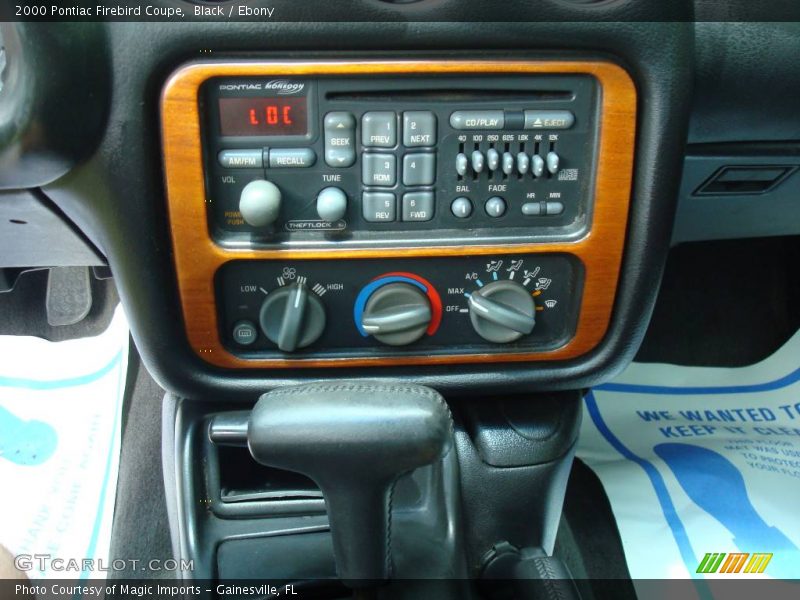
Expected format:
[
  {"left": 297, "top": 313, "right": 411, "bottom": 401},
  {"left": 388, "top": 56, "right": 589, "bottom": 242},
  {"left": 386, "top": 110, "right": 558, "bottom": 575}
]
[{"left": 219, "top": 96, "right": 308, "bottom": 136}]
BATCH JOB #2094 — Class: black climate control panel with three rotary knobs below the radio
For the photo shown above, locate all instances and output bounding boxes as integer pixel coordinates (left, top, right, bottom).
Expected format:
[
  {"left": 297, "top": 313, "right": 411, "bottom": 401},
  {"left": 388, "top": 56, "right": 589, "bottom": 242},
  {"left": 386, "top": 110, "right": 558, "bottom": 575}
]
[{"left": 216, "top": 254, "right": 583, "bottom": 358}]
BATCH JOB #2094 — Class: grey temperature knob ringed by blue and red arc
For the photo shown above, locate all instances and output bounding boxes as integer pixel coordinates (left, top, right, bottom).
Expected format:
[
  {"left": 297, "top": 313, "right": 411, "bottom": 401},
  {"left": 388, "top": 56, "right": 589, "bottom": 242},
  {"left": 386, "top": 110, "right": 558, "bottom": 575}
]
[{"left": 361, "top": 283, "right": 433, "bottom": 346}]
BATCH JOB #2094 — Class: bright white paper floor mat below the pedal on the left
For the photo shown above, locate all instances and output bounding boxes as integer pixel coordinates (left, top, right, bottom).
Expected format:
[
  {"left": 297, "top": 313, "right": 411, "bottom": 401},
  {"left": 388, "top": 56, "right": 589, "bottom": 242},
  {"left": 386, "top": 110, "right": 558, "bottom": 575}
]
[{"left": 0, "top": 307, "right": 128, "bottom": 579}]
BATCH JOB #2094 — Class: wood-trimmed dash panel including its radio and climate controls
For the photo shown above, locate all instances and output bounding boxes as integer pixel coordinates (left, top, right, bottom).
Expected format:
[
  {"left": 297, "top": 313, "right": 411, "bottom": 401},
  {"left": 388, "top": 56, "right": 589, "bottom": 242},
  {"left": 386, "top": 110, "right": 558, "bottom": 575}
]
[{"left": 162, "top": 61, "right": 636, "bottom": 368}]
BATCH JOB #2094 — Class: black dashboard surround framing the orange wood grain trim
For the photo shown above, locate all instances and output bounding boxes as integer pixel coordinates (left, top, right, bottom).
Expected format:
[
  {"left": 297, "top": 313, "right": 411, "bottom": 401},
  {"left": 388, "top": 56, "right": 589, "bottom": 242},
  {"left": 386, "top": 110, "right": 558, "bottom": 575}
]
[{"left": 42, "top": 18, "right": 693, "bottom": 398}]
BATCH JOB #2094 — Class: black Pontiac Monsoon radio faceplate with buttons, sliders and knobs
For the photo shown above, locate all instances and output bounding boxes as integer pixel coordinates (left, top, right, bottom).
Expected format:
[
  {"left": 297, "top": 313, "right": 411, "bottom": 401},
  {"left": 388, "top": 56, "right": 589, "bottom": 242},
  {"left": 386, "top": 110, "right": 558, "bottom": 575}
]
[{"left": 200, "top": 74, "right": 598, "bottom": 247}]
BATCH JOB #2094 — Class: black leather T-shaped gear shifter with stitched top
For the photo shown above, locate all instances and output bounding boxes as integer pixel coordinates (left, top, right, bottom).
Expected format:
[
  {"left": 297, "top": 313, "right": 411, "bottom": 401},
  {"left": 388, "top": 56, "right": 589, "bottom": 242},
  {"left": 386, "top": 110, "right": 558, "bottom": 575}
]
[{"left": 247, "top": 381, "right": 453, "bottom": 587}]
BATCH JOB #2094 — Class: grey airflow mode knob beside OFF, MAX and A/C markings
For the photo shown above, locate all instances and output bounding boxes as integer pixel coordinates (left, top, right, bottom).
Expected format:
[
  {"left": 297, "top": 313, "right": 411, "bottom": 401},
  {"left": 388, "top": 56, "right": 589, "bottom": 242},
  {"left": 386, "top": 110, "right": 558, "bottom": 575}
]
[{"left": 469, "top": 280, "right": 536, "bottom": 344}]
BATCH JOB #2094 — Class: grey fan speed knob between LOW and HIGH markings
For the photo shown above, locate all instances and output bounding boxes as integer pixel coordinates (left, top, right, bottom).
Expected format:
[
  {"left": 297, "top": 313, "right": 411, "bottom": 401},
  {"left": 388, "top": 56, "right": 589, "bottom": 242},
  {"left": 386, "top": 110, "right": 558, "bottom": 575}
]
[{"left": 259, "top": 283, "right": 325, "bottom": 352}]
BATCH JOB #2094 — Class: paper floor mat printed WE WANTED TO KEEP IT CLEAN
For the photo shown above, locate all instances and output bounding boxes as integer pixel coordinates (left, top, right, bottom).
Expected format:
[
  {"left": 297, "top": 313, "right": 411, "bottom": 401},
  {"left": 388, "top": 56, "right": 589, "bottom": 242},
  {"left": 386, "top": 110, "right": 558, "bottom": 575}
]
[{"left": 578, "top": 332, "right": 800, "bottom": 597}]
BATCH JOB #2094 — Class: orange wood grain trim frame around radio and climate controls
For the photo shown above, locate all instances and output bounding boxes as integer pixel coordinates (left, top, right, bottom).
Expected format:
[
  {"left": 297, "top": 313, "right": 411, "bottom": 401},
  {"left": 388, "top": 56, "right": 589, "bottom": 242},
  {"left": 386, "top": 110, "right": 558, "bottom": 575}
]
[{"left": 161, "top": 60, "right": 636, "bottom": 368}]
